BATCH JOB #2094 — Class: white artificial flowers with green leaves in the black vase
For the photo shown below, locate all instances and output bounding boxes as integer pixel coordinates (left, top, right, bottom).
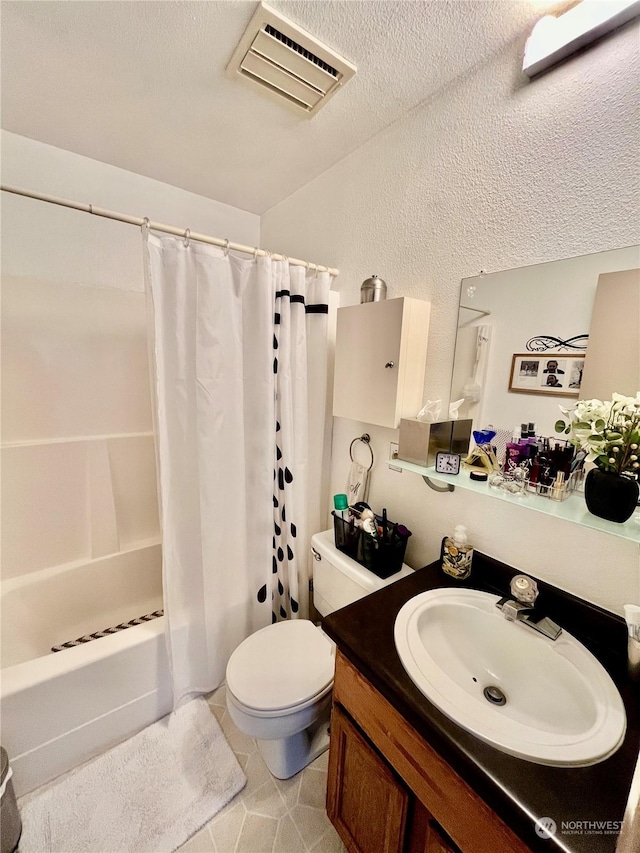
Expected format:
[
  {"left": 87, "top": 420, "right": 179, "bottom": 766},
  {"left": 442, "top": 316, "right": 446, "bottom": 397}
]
[{"left": 555, "top": 391, "right": 640, "bottom": 478}]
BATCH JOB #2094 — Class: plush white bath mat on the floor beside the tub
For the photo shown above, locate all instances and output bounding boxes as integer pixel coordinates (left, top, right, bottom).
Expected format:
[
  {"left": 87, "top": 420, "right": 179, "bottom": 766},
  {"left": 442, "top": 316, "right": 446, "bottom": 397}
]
[{"left": 18, "top": 697, "right": 247, "bottom": 853}]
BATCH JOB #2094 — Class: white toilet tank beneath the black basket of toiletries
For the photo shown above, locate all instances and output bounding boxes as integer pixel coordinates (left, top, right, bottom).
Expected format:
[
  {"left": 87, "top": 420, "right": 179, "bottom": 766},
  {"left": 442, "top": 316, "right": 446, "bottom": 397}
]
[{"left": 311, "top": 528, "right": 413, "bottom": 616}]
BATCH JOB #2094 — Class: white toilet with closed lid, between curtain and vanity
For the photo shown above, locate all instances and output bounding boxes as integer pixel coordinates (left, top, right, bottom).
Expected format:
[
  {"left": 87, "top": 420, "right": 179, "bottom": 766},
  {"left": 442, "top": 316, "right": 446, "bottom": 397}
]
[{"left": 226, "top": 529, "right": 413, "bottom": 779}]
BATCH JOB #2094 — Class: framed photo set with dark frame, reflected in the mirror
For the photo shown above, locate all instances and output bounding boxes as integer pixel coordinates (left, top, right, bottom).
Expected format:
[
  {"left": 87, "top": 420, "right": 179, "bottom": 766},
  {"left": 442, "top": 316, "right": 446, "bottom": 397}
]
[{"left": 509, "top": 352, "right": 584, "bottom": 397}]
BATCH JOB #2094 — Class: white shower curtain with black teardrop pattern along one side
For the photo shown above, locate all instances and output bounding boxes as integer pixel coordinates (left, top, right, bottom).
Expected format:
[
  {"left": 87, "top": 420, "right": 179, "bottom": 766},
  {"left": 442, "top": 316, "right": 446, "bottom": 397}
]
[{"left": 143, "top": 228, "right": 330, "bottom": 707}]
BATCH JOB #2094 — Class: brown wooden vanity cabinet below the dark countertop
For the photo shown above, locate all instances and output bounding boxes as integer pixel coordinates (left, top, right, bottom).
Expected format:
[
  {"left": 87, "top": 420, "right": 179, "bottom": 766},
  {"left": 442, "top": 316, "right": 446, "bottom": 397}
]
[{"left": 327, "top": 652, "right": 530, "bottom": 853}]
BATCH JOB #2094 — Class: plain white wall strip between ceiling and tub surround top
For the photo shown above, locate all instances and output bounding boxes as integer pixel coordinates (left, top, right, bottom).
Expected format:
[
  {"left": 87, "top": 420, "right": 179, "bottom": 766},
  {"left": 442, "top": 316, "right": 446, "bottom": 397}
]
[{"left": 0, "top": 131, "right": 260, "bottom": 291}]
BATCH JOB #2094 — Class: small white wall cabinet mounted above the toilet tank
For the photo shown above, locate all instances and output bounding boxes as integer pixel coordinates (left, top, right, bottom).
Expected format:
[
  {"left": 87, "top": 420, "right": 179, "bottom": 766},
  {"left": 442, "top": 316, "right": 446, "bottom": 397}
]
[{"left": 333, "top": 296, "right": 431, "bottom": 429}]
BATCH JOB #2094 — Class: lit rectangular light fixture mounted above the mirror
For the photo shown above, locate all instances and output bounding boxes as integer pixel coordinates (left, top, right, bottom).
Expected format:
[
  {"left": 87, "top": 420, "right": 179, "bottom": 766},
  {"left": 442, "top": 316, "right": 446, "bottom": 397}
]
[{"left": 522, "top": 0, "right": 640, "bottom": 77}]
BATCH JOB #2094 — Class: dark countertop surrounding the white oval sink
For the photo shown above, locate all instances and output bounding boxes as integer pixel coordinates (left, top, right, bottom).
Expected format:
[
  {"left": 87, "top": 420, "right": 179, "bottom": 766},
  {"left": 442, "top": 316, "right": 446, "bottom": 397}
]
[{"left": 323, "top": 552, "right": 640, "bottom": 853}]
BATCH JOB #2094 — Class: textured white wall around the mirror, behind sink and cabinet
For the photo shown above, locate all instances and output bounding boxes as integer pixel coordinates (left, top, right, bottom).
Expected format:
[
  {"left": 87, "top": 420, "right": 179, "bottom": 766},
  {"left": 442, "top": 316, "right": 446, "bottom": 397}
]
[{"left": 262, "top": 22, "right": 640, "bottom": 612}]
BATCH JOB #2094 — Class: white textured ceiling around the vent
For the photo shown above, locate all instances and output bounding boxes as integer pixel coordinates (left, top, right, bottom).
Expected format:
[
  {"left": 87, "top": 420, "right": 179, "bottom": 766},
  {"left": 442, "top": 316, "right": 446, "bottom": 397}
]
[{"left": 1, "top": 0, "right": 541, "bottom": 213}]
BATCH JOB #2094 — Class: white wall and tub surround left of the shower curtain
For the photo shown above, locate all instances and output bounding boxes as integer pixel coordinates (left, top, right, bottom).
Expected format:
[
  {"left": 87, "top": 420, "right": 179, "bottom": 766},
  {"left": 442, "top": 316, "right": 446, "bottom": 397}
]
[{"left": 1, "top": 133, "right": 260, "bottom": 612}]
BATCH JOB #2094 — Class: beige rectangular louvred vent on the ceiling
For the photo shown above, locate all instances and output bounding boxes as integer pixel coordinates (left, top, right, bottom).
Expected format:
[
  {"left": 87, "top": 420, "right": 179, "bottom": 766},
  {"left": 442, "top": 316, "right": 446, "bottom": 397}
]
[{"left": 227, "top": 3, "right": 356, "bottom": 117}]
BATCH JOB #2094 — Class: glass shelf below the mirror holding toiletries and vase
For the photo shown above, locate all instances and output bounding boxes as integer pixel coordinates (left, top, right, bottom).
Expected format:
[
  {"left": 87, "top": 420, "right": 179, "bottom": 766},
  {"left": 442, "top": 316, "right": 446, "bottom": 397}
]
[{"left": 389, "top": 459, "right": 640, "bottom": 543}]
